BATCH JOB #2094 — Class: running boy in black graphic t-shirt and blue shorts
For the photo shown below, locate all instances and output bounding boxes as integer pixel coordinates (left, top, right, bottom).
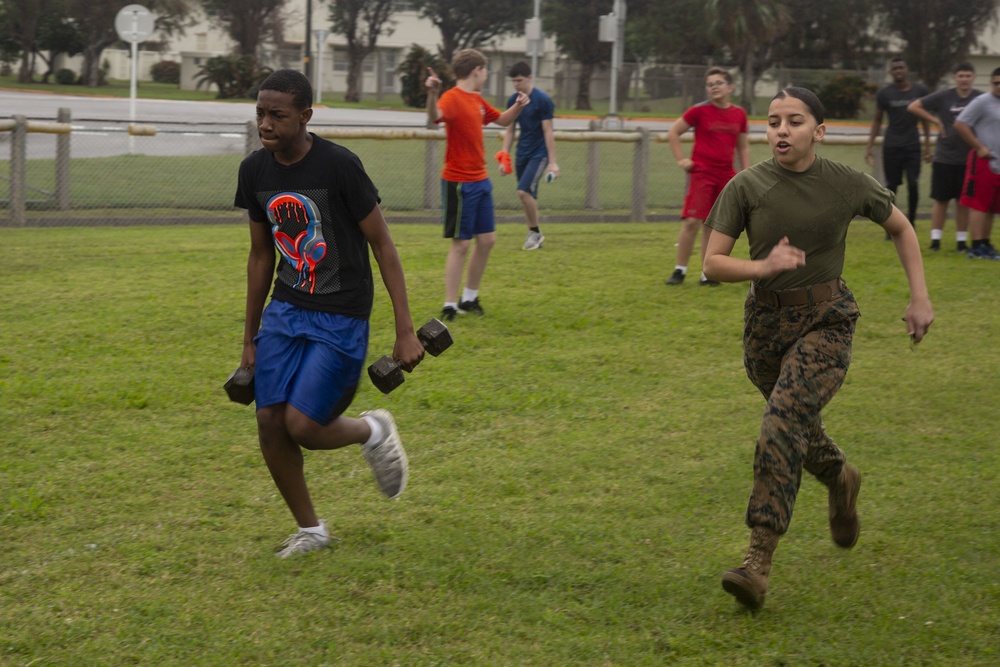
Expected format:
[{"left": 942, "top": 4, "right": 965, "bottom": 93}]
[{"left": 235, "top": 70, "right": 424, "bottom": 558}]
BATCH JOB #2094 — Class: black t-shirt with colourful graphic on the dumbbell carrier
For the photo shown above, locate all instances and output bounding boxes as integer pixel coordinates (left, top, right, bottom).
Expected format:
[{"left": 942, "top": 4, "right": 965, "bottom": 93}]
[{"left": 235, "top": 135, "right": 379, "bottom": 319}]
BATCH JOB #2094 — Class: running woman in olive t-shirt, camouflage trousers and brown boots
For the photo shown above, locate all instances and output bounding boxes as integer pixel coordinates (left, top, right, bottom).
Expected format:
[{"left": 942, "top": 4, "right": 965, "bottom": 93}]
[{"left": 705, "top": 88, "right": 934, "bottom": 609}]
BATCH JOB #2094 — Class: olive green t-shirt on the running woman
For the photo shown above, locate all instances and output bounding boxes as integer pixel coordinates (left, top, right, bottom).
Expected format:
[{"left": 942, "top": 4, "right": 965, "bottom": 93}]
[{"left": 705, "top": 155, "right": 894, "bottom": 290}]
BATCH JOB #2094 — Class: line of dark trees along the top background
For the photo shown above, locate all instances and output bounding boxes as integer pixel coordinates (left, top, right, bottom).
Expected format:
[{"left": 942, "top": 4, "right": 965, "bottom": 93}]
[{"left": 0, "top": 0, "right": 1000, "bottom": 110}]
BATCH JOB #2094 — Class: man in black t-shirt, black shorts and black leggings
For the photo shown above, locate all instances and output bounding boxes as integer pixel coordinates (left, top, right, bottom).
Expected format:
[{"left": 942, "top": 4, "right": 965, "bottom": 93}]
[{"left": 865, "top": 57, "right": 931, "bottom": 232}]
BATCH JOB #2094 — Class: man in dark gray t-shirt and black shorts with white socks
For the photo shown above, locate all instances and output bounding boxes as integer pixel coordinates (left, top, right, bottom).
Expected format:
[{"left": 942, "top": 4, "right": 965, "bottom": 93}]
[{"left": 906, "top": 63, "right": 983, "bottom": 252}]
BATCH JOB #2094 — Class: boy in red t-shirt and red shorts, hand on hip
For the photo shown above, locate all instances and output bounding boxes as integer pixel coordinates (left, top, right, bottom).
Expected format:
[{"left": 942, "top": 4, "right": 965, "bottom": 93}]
[{"left": 667, "top": 67, "right": 750, "bottom": 287}]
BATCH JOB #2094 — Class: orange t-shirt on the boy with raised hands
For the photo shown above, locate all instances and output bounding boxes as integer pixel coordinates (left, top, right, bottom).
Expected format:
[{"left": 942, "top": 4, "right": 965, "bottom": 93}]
[{"left": 437, "top": 88, "right": 500, "bottom": 183}]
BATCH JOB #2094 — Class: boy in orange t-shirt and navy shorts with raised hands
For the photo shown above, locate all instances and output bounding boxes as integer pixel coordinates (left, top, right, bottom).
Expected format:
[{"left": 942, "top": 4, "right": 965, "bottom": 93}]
[{"left": 425, "top": 49, "right": 529, "bottom": 322}]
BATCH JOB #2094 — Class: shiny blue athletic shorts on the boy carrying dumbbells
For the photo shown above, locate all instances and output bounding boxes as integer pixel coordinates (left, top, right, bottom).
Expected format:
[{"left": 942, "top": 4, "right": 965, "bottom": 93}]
[{"left": 254, "top": 299, "right": 368, "bottom": 424}]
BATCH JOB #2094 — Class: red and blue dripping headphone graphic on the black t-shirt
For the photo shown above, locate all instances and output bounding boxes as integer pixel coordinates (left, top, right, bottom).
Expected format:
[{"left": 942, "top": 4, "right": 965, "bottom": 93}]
[{"left": 266, "top": 192, "right": 326, "bottom": 294}]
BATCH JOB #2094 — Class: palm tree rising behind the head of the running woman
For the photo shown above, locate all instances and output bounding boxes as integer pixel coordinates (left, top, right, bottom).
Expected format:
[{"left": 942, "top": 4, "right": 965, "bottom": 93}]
[{"left": 705, "top": 0, "right": 792, "bottom": 113}]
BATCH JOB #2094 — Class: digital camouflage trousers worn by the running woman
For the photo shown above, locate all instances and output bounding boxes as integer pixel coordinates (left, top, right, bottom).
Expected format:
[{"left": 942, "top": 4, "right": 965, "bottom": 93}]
[{"left": 743, "top": 285, "right": 859, "bottom": 534}]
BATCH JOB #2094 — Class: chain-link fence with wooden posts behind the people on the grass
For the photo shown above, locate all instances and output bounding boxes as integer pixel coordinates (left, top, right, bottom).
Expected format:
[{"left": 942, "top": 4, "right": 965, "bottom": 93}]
[{"left": 0, "top": 110, "right": 916, "bottom": 226}]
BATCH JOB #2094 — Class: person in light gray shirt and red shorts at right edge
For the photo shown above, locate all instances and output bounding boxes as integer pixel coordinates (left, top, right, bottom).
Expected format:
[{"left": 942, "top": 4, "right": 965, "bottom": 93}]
[{"left": 955, "top": 67, "right": 1000, "bottom": 259}]
